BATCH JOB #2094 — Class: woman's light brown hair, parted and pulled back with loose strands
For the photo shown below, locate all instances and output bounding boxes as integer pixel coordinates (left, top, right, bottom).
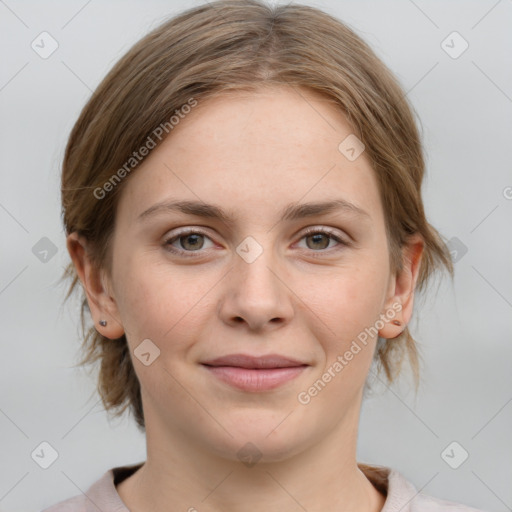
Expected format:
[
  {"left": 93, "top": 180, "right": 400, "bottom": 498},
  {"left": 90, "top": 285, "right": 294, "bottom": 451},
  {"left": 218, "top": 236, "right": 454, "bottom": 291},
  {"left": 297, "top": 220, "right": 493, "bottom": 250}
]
[{"left": 62, "top": 0, "right": 453, "bottom": 429}]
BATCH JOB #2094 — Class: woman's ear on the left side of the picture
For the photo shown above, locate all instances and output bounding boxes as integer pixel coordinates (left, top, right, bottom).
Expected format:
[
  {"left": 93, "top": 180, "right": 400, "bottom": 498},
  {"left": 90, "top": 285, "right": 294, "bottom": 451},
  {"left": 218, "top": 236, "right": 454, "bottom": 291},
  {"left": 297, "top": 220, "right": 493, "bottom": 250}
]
[{"left": 66, "top": 232, "right": 124, "bottom": 339}]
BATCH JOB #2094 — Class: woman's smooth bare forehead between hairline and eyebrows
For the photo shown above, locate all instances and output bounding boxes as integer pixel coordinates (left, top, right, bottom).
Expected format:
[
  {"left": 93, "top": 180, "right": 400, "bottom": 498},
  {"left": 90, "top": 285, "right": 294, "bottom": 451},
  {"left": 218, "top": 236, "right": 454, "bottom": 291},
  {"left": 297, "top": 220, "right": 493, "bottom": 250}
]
[{"left": 114, "top": 86, "right": 382, "bottom": 227}]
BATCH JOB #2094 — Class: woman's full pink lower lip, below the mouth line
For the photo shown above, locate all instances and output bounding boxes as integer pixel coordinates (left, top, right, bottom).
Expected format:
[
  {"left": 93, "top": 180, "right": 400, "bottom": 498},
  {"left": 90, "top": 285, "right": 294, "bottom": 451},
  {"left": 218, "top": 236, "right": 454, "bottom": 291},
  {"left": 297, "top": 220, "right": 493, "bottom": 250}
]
[{"left": 203, "top": 365, "right": 306, "bottom": 391}]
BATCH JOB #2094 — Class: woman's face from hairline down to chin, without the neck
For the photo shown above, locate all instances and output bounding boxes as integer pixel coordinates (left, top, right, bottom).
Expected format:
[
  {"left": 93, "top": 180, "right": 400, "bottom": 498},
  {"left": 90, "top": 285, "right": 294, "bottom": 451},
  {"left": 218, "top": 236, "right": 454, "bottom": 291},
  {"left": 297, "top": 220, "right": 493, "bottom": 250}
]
[{"left": 80, "top": 87, "right": 418, "bottom": 461}]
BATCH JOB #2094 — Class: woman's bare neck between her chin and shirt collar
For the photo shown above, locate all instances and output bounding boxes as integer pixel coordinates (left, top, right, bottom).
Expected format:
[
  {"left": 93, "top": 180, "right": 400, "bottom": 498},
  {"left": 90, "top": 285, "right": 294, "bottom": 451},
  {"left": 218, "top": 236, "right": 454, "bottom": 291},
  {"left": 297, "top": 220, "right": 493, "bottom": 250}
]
[{"left": 117, "top": 406, "right": 385, "bottom": 512}]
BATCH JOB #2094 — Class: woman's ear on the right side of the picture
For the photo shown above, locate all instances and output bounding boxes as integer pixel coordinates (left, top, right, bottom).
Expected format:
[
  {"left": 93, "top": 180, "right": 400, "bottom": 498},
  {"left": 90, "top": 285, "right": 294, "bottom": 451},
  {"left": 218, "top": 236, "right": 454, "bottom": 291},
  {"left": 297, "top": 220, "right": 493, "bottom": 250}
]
[{"left": 379, "top": 234, "right": 425, "bottom": 339}]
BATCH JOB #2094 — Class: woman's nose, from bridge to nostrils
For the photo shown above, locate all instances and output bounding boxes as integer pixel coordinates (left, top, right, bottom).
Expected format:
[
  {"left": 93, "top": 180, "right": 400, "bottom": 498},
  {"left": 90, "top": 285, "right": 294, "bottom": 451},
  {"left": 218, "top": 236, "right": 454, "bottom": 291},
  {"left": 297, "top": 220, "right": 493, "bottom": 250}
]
[{"left": 219, "top": 243, "right": 294, "bottom": 331}]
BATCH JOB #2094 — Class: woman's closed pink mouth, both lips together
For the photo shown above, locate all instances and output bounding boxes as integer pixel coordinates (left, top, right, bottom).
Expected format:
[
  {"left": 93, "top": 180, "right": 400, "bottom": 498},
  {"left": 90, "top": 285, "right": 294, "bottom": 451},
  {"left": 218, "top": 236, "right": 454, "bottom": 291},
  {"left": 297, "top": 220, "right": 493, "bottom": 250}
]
[{"left": 201, "top": 354, "right": 309, "bottom": 392}]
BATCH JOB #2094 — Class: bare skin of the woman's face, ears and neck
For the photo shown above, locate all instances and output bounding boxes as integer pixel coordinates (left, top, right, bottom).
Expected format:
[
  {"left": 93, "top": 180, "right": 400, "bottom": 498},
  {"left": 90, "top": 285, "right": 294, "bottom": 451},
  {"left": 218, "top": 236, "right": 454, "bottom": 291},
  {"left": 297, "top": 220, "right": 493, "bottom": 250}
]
[{"left": 68, "top": 86, "right": 423, "bottom": 512}]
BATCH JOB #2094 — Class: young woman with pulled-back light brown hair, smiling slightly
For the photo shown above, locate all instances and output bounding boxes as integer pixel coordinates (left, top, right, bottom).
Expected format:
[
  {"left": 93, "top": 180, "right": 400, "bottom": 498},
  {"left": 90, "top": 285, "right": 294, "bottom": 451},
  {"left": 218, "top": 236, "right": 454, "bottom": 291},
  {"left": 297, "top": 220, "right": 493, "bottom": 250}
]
[{"left": 46, "top": 0, "right": 484, "bottom": 512}]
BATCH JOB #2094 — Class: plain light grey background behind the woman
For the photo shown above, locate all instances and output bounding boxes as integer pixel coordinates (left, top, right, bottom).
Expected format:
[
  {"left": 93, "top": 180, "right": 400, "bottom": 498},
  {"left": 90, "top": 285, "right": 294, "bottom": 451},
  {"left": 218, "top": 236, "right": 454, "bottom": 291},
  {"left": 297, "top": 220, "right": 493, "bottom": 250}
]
[{"left": 0, "top": 0, "right": 512, "bottom": 512}]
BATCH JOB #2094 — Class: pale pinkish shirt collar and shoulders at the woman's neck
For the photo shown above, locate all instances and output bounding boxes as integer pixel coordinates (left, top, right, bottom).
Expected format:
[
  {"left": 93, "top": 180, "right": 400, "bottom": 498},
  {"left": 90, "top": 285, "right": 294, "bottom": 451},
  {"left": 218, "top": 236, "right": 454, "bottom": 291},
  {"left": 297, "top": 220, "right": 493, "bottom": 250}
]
[{"left": 42, "top": 463, "right": 484, "bottom": 512}]
